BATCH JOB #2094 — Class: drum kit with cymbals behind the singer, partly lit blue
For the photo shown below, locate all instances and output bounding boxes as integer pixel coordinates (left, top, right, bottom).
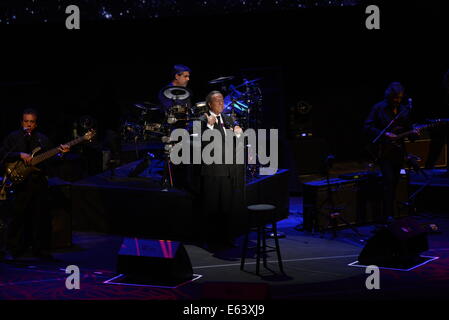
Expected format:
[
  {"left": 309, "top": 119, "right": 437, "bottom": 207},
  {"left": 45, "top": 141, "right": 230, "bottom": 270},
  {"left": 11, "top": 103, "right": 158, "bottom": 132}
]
[{"left": 120, "top": 76, "right": 262, "bottom": 142}]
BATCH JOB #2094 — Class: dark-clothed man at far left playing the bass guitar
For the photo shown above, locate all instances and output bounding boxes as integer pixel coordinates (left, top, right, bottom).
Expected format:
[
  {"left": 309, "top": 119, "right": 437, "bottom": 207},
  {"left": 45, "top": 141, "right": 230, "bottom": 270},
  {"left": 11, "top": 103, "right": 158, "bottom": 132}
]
[{"left": 2, "top": 109, "right": 69, "bottom": 260}]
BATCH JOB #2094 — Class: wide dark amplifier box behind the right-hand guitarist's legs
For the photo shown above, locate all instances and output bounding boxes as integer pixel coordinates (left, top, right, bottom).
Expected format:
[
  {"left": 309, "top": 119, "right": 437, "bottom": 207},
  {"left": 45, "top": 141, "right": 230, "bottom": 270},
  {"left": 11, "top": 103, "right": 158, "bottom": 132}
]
[{"left": 303, "top": 175, "right": 408, "bottom": 231}]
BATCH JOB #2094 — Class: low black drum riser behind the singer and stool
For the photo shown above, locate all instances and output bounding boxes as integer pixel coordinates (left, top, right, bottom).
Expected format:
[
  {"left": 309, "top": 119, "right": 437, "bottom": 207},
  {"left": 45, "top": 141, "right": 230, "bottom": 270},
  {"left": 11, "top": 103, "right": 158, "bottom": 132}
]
[{"left": 72, "top": 170, "right": 289, "bottom": 241}]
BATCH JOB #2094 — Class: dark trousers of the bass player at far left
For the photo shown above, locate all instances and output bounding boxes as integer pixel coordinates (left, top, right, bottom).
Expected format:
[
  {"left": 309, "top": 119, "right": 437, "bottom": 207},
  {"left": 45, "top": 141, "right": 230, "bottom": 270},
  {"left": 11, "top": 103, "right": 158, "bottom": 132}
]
[{"left": 6, "top": 176, "right": 51, "bottom": 254}]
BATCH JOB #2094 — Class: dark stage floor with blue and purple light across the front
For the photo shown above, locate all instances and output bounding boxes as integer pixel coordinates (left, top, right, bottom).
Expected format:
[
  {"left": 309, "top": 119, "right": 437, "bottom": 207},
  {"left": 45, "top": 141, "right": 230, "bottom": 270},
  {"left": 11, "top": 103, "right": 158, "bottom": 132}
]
[{"left": 0, "top": 198, "right": 449, "bottom": 301}]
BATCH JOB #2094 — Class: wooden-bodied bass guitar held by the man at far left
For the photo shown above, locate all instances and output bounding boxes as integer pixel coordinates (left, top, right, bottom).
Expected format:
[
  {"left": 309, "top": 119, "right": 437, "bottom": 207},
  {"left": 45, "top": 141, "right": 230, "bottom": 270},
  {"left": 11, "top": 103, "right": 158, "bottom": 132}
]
[{"left": 3, "top": 130, "right": 95, "bottom": 184}]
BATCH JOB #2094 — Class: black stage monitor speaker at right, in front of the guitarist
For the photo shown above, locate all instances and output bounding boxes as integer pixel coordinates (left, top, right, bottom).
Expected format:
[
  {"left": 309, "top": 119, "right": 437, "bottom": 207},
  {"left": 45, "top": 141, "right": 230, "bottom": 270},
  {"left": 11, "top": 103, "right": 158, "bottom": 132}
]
[{"left": 359, "top": 217, "right": 429, "bottom": 268}]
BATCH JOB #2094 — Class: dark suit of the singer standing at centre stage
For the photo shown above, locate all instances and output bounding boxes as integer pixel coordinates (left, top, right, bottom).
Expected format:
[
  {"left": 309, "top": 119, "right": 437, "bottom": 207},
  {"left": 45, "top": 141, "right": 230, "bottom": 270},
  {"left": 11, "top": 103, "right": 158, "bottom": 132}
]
[{"left": 200, "top": 114, "right": 245, "bottom": 244}]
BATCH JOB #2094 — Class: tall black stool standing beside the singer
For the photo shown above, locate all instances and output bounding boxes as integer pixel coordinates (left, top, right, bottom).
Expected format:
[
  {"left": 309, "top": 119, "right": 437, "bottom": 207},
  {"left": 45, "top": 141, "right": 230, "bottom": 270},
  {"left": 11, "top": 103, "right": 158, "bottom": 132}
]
[{"left": 240, "top": 204, "right": 284, "bottom": 275}]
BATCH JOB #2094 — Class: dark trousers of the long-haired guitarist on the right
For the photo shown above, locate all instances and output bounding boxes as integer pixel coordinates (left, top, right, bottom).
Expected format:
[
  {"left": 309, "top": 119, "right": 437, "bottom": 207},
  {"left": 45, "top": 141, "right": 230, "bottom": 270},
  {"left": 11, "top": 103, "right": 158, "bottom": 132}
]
[{"left": 378, "top": 159, "right": 402, "bottom": 223}]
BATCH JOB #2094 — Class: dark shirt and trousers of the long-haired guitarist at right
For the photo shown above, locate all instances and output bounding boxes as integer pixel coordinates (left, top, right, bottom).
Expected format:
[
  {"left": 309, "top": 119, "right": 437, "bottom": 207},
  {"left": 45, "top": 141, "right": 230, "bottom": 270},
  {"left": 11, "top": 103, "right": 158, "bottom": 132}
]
[{"left": 365, "top": 100, "right": 412, "bottom": 223}]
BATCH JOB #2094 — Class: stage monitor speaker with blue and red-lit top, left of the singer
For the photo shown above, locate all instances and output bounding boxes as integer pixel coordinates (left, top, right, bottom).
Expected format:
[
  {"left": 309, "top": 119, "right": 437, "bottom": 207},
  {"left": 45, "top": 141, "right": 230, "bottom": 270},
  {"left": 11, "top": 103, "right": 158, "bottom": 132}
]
[{"left": 117, "top": 238, "right": 193, "bottom": 285}]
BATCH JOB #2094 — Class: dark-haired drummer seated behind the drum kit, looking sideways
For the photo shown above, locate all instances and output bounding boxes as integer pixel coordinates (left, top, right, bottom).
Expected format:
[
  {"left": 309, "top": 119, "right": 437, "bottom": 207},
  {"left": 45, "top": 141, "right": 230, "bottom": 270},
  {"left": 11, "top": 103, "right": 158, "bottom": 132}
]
[{"left": 158, "top": 64, "right": 192, "bottom": 111}]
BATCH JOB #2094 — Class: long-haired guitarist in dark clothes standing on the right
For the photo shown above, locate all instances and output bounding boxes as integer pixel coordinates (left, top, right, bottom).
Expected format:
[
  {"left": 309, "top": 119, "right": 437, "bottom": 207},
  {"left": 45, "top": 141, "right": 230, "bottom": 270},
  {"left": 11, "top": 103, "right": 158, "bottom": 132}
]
[{"left": 364, "top": 82, "right": 412, "bottom": 224}]
